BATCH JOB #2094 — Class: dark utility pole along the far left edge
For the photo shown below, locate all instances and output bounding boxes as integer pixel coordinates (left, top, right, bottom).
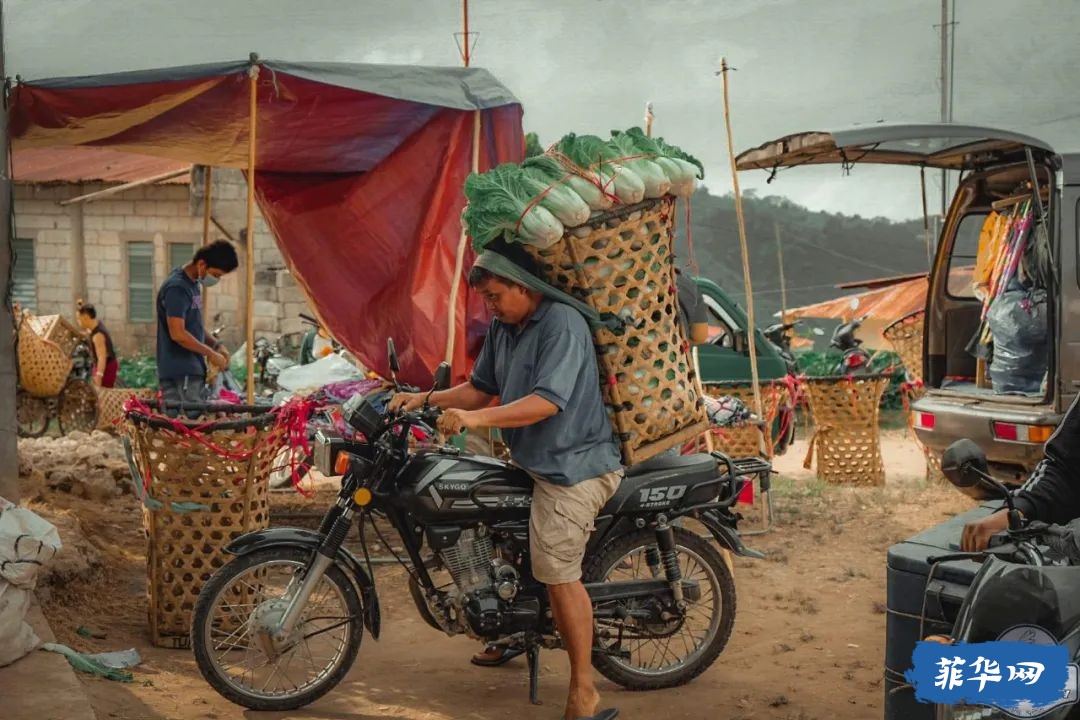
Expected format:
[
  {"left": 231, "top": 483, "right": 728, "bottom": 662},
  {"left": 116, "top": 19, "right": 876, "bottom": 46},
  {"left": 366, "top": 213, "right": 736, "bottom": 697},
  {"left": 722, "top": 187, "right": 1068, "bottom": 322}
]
[{"left": 0, "top": 2, "right": 18, "bottom": 503}]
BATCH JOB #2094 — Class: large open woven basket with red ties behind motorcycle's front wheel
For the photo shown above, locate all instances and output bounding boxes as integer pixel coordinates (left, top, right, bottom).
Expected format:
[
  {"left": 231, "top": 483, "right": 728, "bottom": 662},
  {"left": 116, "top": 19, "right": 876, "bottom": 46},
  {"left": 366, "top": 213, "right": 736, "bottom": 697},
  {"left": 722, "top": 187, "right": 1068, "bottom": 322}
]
[{"left": 125, "top": 403, "right": 285, "bottom": 648}]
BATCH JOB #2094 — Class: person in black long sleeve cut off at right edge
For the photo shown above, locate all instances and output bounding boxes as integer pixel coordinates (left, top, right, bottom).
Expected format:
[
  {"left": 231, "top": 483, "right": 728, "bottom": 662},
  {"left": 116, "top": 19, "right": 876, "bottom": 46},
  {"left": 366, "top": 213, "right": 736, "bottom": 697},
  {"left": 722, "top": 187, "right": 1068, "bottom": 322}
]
[{"left": 960, "top": 396, "right": 1080, "bottom": 553}]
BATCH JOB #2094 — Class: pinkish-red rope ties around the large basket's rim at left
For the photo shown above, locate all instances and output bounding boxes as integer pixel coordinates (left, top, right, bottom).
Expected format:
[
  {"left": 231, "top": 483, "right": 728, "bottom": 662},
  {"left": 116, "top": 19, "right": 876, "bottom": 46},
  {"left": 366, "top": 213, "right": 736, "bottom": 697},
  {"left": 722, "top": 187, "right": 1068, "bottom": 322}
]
[{"left": 124, "top": 396, "right": 324, "bottom": 497}]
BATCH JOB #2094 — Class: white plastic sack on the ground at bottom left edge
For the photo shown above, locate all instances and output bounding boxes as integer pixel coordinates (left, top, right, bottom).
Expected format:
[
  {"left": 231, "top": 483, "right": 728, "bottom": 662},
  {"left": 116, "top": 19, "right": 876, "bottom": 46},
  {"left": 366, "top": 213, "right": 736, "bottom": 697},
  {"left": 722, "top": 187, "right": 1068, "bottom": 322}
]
[{"left": 0, "top": 498, "right": 60, "bottom": 667}]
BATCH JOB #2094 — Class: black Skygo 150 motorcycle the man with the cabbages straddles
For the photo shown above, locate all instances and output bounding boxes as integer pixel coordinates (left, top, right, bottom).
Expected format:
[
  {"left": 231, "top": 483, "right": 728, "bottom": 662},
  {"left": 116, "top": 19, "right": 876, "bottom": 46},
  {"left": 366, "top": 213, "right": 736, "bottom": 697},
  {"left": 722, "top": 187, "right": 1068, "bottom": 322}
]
[{"left": 191, "top": 341, "right": 771, "bottom": 711}]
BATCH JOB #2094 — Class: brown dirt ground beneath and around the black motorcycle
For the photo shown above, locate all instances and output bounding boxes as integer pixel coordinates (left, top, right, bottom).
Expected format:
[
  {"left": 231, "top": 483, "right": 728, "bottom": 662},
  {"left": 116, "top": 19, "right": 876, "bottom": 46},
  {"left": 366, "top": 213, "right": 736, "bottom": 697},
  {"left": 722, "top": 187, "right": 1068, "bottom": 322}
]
[{"left": 21, "top": 431, "right": 972, "bottom": 720}]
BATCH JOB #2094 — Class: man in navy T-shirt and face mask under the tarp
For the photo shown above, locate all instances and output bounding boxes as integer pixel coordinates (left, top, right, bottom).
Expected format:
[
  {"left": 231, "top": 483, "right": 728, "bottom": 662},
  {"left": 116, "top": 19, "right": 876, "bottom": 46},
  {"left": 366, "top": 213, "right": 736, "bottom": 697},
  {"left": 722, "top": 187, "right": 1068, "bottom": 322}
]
[{"left": 157, "top": 240, "right": 240, "bottom": 416}]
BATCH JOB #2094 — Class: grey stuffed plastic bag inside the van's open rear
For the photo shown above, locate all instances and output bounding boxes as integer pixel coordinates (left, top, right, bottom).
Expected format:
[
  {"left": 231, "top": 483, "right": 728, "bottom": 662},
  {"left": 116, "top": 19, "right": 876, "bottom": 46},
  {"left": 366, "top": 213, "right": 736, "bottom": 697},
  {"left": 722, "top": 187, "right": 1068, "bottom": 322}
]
[{"left": 986, "top": 290, "right": 1050, "bottom": 393}]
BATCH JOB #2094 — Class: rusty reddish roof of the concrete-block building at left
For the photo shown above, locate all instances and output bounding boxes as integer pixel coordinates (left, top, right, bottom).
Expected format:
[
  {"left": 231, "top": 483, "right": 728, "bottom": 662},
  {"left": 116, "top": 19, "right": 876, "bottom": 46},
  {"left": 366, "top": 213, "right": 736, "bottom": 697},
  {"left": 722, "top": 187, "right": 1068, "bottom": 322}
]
[{"left": 12, "top": 146, "right": 191, "bottom": 185}]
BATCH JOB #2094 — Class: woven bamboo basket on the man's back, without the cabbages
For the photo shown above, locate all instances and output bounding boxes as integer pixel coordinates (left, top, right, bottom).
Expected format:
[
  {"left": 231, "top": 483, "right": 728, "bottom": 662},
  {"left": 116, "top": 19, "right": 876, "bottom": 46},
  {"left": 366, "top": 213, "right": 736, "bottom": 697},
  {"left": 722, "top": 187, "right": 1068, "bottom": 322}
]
[{"left": 529, "top": 195, "right": 708, "bottom": 465}]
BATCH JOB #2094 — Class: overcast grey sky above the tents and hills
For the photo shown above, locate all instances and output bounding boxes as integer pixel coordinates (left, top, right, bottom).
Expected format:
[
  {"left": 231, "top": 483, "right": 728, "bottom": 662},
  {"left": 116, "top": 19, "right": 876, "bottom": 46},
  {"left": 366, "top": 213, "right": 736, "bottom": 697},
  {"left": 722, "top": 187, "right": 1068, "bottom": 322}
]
[{"left": 3, "top": 0, "right": 1080, "bottom": 218}]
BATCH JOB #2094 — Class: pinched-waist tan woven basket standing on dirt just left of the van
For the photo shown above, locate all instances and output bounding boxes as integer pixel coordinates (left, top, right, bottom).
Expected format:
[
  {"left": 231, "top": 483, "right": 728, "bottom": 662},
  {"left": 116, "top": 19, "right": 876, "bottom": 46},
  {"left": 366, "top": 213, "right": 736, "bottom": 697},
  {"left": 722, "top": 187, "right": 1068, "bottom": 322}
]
[{"left": 802, "top": 375, "right": 889, "bottom": 485}]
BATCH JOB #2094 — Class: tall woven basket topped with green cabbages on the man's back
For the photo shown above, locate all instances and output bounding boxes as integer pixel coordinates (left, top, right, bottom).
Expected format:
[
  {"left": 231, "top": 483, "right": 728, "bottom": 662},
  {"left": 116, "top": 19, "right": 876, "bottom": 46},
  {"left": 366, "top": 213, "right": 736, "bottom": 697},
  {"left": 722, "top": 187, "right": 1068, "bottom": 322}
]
[{"left": 463, "top": 128, "right": 708, "bottom": 465}]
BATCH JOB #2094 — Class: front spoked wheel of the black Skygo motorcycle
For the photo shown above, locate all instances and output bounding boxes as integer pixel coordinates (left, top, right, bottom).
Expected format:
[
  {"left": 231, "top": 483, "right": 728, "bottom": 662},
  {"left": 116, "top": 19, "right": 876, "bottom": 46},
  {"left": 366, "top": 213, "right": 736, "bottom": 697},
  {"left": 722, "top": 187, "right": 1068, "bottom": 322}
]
[{"left": 191, "top": 547, "right": 363, "bottom": 710}]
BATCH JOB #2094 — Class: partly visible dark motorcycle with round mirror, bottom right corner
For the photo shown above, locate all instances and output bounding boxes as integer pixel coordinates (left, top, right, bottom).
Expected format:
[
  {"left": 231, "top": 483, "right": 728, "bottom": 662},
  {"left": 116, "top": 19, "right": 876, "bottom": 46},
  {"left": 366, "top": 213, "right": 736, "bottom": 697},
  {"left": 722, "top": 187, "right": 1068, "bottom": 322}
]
[{"left": 929, "top": 439, "right": 1080, "bottom": 720}]
